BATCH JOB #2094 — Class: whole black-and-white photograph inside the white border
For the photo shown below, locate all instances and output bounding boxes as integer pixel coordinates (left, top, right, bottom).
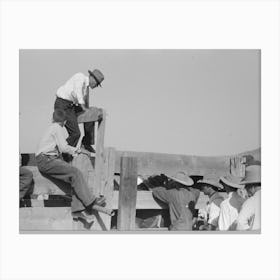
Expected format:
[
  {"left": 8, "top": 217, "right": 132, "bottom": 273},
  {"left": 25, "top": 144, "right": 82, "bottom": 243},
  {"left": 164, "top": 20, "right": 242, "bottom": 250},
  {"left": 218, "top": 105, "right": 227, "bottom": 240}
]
[{"left": 19, "top": 49, "right": 261, "bottom": 233}]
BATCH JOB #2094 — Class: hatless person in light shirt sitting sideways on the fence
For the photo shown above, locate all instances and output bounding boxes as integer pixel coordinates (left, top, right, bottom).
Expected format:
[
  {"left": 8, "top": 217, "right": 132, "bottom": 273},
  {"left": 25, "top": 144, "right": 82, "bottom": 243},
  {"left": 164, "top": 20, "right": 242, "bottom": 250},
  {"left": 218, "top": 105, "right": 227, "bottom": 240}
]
[{"left": 36, "top": 109, "right": 105, "bottom": 222}]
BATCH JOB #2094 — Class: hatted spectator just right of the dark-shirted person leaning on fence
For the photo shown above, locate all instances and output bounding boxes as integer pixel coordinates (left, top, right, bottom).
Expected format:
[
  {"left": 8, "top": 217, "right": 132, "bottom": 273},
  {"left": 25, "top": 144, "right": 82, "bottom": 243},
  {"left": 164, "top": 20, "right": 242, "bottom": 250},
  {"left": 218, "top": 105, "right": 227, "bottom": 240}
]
[{"left": 196, "top": 175, "right": 224, "bottom": 230}]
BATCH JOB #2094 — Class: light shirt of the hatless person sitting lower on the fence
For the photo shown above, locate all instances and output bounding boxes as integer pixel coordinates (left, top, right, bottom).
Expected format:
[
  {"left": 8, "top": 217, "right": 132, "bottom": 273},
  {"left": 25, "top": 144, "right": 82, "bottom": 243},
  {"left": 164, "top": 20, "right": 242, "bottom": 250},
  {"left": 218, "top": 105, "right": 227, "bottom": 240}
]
[{"left": 36, "top": 123, "right": 77, "bottom": 155}]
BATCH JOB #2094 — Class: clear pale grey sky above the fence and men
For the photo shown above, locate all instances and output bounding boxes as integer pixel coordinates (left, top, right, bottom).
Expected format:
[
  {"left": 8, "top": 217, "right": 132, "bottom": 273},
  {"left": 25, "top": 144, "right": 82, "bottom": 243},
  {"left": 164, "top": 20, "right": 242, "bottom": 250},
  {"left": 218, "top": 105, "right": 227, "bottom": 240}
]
[{"left": 19, "top": 49, "right": 261, "bottom": 156}]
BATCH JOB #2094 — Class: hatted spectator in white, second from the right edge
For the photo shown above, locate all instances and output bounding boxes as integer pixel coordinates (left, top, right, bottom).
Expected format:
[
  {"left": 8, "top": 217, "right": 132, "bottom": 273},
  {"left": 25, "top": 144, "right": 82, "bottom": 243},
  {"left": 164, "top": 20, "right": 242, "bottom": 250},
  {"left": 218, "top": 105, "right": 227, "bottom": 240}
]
[{"left": 218, "top": 174, "right": 247, "bottom": 230}]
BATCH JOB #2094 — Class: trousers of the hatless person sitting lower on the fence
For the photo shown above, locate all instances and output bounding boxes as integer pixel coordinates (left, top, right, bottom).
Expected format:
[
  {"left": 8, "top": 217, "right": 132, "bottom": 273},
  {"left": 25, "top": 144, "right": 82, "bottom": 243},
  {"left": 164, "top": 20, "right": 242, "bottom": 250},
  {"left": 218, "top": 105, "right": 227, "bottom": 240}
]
[{"left": 36, "top": 154, "right": 96, "bottom": 212}]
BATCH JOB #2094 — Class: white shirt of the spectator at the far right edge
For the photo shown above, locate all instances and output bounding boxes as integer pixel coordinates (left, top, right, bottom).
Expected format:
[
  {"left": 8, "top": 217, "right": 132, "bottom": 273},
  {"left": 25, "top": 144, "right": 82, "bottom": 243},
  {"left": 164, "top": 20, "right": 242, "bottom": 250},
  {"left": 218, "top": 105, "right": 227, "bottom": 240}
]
[{"left": 237, "top": 190, "right": 261, "bottom": 230}]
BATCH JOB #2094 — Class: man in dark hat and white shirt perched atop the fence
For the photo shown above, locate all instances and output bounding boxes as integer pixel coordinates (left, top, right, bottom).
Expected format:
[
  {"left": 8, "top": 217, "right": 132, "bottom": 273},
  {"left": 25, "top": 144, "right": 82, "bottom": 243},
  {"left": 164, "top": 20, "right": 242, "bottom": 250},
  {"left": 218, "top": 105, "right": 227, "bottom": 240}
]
[{"left": 54, "top": 69, "right": 104, "bottom": 152}]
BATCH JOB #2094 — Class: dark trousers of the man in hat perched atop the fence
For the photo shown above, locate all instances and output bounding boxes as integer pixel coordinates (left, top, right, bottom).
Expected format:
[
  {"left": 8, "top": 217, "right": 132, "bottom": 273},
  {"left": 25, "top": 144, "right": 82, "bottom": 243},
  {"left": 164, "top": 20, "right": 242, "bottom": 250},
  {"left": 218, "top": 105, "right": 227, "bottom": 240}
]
[{"left": 54, "top": 97, "right": 94, "bottom": 147}]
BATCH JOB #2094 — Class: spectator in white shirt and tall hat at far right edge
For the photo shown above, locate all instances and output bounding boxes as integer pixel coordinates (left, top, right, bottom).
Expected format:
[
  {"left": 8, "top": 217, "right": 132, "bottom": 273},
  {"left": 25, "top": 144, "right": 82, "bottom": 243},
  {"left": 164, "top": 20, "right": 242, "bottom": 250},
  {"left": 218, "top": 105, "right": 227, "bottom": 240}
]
[{"left": 237, "top": 165, "right": 261, "bottom": 230}]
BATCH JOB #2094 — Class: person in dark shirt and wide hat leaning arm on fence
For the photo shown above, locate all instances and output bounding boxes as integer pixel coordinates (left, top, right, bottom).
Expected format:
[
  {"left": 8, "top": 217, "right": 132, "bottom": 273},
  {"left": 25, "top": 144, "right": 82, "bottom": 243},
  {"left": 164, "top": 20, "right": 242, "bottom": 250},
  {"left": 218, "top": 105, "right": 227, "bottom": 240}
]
[{"left": 152, "top": 171, "right": 200, "bottom": 230}]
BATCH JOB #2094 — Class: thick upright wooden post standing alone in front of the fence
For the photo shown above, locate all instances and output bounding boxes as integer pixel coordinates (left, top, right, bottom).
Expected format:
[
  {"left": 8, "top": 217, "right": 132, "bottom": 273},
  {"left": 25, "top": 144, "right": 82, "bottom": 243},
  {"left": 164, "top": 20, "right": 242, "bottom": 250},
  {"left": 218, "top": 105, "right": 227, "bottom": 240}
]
[{"left": 117, "top": 157, "right": 137, "bottom": 230}]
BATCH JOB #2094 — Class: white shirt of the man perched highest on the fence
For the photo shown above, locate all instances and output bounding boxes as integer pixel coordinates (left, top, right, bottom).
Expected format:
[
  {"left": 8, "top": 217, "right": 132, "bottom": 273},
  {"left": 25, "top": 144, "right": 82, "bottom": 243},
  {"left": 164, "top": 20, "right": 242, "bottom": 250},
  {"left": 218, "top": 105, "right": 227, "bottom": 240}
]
[{"left": 56, "top": 73, "right": 89, "bottom": 104}]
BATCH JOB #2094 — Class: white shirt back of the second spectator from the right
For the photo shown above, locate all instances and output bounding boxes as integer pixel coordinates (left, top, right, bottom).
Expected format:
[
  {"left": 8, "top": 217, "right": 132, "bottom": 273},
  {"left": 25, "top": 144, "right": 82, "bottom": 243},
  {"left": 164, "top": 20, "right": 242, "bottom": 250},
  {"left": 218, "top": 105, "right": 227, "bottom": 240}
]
[{"left": 218, "top": 192, "right": 238, "bottom": 230}]
